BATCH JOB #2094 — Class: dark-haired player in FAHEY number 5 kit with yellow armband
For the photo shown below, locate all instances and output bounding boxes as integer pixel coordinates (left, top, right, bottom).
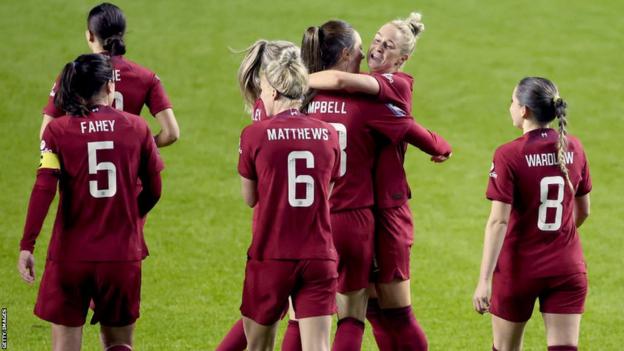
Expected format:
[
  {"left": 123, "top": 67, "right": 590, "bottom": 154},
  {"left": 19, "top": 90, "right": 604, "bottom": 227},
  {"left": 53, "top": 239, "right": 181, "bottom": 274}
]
[{"left": 18, "top": 54, "right": 163, "bottom": 351}]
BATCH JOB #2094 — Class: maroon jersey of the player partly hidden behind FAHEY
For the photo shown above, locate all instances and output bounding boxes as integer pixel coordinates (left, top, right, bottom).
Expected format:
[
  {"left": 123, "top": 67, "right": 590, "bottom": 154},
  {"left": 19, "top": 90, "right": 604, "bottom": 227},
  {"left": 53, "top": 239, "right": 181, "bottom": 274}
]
[{"left": 43, "top": 56, "right": 171, "bottom": 117}]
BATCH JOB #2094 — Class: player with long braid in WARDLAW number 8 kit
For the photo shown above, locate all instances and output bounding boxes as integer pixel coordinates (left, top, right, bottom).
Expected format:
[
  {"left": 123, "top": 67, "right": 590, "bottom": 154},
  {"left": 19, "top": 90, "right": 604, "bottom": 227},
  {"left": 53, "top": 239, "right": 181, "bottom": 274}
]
[{"left": 473, "top": 77, "right": 592, "bottom": 351}]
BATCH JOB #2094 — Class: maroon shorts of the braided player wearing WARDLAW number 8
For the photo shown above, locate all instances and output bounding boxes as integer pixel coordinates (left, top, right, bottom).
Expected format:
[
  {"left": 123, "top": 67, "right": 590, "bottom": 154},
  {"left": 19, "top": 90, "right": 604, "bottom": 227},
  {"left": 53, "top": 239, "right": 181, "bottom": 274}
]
[{"left": 490, "top": 272, "right": 587, "bottom": 323}]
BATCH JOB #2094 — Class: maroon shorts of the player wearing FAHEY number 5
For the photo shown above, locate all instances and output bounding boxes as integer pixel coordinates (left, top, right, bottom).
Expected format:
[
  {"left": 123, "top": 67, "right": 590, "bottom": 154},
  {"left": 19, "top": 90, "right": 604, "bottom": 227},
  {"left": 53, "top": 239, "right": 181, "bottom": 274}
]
[{"left": 35, "top": 260, "right": 141, "bottom": 327}]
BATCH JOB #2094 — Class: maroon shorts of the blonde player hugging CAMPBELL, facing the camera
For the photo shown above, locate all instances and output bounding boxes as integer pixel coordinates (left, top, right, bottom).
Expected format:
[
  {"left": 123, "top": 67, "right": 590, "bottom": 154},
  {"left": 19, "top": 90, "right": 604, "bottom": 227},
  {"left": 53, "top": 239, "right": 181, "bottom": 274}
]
[{"left": 375, "top": 203, "right": 414, "bottom": 283}]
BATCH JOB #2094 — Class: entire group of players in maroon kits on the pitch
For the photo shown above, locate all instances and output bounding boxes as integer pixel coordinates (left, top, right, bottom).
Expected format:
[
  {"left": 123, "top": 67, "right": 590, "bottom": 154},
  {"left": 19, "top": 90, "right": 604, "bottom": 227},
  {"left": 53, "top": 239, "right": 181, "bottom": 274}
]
[{"left": 18, "top": 3, "right": 591, "bottom": 351}]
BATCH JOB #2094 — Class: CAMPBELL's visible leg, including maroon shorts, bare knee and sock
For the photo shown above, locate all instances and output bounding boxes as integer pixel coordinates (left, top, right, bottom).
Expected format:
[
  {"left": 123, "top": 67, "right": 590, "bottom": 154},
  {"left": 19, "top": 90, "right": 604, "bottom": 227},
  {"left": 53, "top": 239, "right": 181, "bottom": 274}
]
[{"left": 331, "top": 209, "right": 375, "bottom": 351}]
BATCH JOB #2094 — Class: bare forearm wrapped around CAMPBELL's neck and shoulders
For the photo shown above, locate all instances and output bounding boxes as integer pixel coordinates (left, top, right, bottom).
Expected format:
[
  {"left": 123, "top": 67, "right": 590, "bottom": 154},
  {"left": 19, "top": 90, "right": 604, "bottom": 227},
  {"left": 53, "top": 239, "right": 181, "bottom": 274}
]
[{"left": 309, "top": 70, "right": 379, "bottom": 95}]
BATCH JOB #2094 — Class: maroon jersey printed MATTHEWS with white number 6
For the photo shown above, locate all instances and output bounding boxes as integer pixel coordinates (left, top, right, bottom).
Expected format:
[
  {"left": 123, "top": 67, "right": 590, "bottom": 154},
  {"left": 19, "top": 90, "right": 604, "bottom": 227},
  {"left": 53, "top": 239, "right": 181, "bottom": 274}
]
[{"left": 238, "top": 110, "right": 340, "bottom": 260}]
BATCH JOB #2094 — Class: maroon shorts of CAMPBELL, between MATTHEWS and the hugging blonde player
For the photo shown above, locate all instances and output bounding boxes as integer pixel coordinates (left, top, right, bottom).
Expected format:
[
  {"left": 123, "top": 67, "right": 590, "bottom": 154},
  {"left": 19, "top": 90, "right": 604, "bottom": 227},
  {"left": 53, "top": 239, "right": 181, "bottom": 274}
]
[{"left": 331, "top": 208, "right": 375, "bottom": 293}]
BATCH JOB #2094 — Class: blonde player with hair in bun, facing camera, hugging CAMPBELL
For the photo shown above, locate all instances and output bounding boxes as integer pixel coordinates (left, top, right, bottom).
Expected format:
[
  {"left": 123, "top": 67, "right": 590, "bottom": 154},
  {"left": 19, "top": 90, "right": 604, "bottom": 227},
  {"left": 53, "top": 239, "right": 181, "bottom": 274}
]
[{"left": 310, "top": 12, "right": 438, "bottom": 351}]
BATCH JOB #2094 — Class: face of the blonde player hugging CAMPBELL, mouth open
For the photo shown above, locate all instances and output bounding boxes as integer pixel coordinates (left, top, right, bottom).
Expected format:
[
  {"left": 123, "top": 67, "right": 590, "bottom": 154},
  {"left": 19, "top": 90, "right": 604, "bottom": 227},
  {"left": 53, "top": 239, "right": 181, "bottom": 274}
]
[{"left": 367, "top": 23, "right": 408, "bottom": 73}]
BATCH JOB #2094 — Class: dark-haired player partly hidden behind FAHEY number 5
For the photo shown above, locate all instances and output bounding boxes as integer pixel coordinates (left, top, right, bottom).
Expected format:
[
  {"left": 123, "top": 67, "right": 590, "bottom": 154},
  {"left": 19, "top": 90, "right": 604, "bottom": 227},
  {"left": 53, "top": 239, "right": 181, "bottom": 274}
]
[{"left": 40, "top": 3, "right": 180, "bottom": 147}]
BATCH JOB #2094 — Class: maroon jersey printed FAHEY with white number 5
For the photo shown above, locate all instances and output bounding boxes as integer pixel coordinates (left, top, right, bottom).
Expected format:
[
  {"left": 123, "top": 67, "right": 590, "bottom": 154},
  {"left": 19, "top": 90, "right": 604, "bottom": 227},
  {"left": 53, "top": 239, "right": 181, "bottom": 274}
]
[{"left": 41, "top": 106, "right": 163, "bottom": 261}]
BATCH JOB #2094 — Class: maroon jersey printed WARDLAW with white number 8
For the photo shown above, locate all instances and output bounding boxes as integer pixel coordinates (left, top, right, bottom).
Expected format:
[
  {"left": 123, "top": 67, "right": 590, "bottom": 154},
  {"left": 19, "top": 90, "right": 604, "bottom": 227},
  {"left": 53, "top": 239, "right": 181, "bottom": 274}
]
[{"left": 486, "top": 129, "right": 591, "bottom": 277}]
